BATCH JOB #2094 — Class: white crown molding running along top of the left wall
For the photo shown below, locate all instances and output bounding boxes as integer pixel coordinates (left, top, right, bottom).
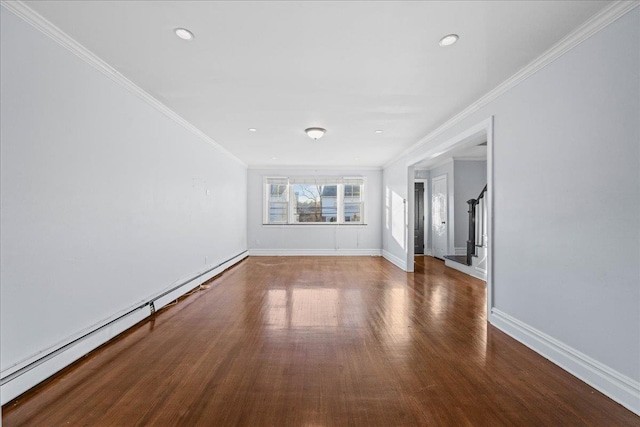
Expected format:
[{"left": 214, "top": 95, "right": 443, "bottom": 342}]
[{"left": 0, "top": 0, "right": 247, "bottom": 167}]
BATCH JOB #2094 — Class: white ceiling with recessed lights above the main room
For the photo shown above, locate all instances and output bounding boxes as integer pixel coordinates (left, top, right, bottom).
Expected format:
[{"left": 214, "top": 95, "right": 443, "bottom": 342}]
[{"left": 25, "top": 1, "right": 608, "bottom": 167}]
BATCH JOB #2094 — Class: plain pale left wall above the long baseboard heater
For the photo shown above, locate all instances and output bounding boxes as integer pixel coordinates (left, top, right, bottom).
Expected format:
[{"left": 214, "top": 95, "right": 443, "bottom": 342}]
[{"left": 0, "top": 8, "right": 247, "bottom": 403}]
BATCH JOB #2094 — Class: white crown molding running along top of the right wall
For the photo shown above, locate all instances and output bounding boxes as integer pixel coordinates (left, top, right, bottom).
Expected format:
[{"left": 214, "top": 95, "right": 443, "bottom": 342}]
[{"left": 383, "top": 0, "right": 640, "bottom": 169}]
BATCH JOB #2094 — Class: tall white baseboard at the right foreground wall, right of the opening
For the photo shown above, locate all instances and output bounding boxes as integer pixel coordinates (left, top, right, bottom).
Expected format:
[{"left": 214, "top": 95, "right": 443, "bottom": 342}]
[{"left": 490, "top": 308, "right": 640, "bottom": 415}]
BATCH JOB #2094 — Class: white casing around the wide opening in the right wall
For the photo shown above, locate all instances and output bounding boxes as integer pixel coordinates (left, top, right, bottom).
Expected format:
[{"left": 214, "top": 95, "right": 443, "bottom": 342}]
[{"left": 406, "top": 116, "right": 495, "bottom": 321}]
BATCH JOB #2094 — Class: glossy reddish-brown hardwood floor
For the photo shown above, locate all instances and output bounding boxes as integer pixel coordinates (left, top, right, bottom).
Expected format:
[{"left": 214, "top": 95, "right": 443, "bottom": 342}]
[{"left": 2, "top": 257, "right": 640, "bottom": 427}]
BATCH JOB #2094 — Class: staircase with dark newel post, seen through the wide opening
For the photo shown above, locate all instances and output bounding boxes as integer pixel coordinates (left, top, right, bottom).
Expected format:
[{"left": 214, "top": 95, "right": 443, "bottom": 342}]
[{"left": 444, "top": 185, "right": 487, "bottom": 280}]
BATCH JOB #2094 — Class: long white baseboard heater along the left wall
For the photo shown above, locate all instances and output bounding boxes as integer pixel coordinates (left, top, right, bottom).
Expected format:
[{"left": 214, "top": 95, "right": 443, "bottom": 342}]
[{"left": 0, "top": 251, "right": 248, "bottom": 394}]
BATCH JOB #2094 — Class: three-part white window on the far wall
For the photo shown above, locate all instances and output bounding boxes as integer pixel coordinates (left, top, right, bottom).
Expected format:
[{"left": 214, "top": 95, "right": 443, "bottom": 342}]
[{"left": 264, "top": 177, "right": 364, "bottom": 224}]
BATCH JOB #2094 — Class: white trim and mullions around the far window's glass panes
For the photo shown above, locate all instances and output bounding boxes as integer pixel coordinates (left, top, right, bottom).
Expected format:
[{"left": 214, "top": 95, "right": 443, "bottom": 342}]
[{"left": 262, "top": 175, "right": 368, "bottom": 227}]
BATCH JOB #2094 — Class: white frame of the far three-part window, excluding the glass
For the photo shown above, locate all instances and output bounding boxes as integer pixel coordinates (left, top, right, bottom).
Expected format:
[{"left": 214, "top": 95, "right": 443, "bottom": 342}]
[{"left": 262, "top": 175, "right": 367, "bottom": 226}]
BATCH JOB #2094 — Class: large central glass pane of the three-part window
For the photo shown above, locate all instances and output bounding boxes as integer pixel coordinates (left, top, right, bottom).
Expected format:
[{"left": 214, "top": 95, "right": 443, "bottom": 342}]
[{"left": 293, "top": 184, "right": 338, "bottom": 222}]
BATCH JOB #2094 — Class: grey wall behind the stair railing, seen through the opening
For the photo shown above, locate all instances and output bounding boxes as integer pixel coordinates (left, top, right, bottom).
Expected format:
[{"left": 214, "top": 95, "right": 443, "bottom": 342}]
[{"left": 453, "top": 160, "right": 487, "bottom": 247}]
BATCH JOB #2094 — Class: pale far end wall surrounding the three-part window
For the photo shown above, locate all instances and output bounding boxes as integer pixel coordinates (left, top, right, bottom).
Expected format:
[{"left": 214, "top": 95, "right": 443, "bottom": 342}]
[{"left": 247, "top": 169, "right": 382, "bottom": 255}]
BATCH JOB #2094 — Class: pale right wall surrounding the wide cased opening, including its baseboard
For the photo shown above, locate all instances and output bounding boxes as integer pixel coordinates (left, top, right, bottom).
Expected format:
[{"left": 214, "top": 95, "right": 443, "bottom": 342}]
[{"left": 383, "top": 8, "right": 640, "bottom": 412}]
